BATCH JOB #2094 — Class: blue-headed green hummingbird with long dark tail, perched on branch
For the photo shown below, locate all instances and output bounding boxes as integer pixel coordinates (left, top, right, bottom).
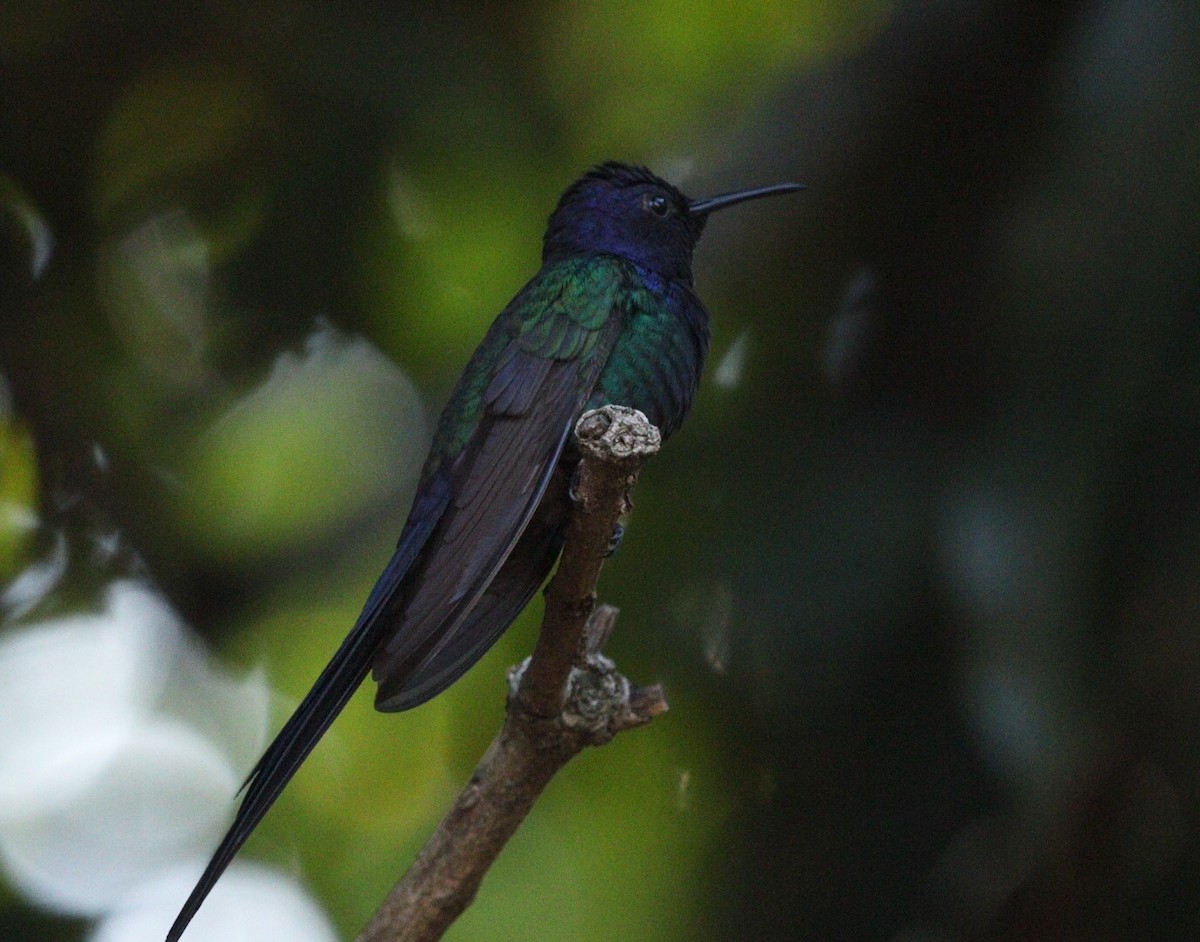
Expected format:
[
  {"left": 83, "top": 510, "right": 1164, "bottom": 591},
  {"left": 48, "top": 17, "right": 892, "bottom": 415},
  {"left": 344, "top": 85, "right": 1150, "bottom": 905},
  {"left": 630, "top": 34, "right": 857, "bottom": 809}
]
[{"left": 167, "top": 161, "right": 802, "bottom": 942}]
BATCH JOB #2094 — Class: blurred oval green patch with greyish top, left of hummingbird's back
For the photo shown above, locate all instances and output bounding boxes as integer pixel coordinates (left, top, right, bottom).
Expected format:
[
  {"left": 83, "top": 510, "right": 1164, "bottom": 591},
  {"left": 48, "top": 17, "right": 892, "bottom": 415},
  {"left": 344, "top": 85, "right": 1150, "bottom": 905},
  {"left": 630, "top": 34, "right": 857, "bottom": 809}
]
[{"left": 180, "top": 330, "right": 428, "bottom": 558}]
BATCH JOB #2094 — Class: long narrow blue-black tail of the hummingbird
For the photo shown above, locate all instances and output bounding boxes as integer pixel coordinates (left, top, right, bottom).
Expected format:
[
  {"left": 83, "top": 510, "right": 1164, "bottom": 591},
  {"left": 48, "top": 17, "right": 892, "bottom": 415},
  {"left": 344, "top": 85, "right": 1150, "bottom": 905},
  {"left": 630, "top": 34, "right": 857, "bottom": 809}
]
[{"left": 167, "top": 479, "right": 449, "bottom": 942}]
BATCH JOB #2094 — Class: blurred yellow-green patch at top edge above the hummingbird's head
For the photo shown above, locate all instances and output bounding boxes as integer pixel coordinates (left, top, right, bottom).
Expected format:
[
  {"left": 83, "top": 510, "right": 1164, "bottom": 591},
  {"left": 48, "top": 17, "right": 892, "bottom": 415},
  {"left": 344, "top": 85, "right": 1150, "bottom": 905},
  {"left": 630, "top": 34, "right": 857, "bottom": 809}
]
[{"left": 538, "top": 0, "right": 892, "bottom": 160}]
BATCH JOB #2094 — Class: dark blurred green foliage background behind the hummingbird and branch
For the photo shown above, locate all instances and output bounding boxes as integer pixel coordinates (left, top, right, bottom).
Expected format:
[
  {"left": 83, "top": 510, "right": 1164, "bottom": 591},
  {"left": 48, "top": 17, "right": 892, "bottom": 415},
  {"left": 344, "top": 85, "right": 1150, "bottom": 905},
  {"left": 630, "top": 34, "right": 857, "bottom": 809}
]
[{"left": 0, "top": 0, "right": 1200, "bottom": 942}]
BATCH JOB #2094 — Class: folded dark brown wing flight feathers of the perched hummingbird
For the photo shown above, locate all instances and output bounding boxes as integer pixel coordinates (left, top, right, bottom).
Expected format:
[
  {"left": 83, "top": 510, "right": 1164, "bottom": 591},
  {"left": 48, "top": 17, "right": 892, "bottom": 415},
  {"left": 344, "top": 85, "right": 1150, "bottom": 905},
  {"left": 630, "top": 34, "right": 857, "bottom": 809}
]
[{"left": 372, "top": 290, "right": 623, "bottom": 710}]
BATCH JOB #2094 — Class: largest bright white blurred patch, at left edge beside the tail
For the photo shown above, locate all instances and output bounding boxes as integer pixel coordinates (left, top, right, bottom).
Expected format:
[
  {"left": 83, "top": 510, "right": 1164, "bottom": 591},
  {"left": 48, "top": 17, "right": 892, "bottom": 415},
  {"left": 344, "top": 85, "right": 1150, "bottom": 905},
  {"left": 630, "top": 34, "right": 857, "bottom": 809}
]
[{"left": 0, "top": 581, "right": 268, "bottom": 916}]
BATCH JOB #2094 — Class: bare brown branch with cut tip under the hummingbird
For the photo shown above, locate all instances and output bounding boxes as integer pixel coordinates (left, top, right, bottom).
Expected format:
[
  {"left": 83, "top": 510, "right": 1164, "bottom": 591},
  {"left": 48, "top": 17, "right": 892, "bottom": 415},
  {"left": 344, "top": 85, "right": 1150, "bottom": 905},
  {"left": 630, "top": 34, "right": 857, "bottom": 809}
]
[{"left": 358, "top": 406, "right": 667, "bottom": 942}]
